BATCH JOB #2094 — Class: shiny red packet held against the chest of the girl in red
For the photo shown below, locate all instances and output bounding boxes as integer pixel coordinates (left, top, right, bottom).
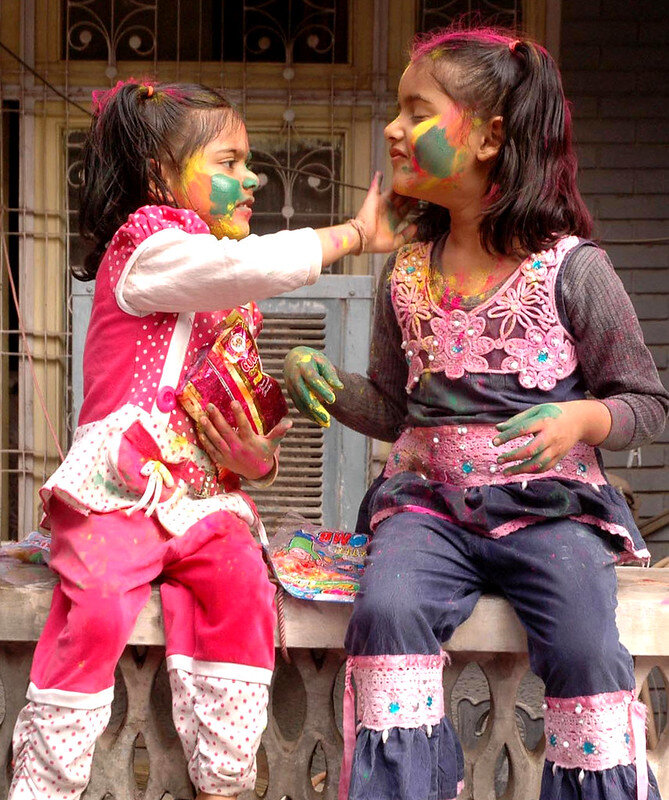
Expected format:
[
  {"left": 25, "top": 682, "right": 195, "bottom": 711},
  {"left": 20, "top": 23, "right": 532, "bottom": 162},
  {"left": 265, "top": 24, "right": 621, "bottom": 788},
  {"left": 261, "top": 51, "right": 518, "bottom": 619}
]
[{"left": 177, "top": 311, "right": 288, "bottom": 435}]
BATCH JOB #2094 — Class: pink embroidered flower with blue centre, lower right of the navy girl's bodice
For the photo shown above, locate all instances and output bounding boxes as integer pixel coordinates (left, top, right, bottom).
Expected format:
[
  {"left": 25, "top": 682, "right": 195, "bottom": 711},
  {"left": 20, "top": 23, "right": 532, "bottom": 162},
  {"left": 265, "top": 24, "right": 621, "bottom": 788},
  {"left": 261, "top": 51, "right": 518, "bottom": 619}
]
[{"left": 502, "top": 325, "right": 576, "bottom": 391}]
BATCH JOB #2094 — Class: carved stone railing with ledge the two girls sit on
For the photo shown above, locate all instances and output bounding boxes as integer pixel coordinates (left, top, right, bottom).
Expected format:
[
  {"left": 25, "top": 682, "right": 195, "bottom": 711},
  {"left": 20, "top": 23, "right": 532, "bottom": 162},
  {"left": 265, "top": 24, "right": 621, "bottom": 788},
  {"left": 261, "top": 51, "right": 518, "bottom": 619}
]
[{"left": 0, "top": 562, "right": 669, "bottom": 800}]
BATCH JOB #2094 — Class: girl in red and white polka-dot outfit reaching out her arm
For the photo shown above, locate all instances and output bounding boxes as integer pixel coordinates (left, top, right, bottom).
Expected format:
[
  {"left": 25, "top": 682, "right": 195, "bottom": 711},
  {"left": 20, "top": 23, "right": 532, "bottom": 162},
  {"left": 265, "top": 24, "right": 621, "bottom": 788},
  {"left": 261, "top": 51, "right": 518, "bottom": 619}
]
[{"left": 9, "top": 80, "right": 410, "bottom": 800}]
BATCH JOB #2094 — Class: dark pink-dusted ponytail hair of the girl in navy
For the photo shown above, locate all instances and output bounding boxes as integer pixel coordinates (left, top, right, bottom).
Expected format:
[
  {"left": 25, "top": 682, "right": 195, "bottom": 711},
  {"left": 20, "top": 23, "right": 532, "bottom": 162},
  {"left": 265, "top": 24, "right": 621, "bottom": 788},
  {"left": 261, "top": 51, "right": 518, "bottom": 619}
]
[{"left": 411, "top": 28, "right": 592, "bottom": 255}]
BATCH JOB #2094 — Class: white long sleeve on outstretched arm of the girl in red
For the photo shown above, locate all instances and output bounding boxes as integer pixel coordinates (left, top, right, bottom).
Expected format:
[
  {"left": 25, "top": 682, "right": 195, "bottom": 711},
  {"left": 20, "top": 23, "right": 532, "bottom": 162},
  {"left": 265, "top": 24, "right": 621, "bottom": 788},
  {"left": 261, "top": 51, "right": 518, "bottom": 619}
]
[{"left": 116, "top": 228, "right": 323, "bottom": 316}]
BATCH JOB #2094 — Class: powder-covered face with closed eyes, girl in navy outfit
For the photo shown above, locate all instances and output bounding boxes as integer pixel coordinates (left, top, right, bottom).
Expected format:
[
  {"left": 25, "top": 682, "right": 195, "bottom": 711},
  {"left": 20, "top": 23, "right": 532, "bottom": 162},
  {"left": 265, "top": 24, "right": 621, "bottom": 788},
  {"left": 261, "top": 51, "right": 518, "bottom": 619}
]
[{"left": 385, "top": 62, "right": 479, "bottom": 207}]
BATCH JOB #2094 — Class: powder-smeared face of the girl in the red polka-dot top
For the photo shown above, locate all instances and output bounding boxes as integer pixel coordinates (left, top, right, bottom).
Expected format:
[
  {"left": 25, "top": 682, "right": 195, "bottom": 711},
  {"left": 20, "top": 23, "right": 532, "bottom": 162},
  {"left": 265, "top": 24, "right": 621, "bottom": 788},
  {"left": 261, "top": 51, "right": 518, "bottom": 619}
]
[{"left": 170, "top": 125, "right": 259, "bottom": 239}]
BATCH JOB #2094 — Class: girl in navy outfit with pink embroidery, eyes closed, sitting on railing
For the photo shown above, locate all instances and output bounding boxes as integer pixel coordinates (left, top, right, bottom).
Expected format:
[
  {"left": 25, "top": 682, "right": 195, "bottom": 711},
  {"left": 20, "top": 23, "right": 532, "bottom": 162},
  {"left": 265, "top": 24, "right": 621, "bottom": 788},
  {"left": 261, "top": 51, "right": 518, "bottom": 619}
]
[{"left": 285, "top": 30, "right": 669, "bottom": 800}]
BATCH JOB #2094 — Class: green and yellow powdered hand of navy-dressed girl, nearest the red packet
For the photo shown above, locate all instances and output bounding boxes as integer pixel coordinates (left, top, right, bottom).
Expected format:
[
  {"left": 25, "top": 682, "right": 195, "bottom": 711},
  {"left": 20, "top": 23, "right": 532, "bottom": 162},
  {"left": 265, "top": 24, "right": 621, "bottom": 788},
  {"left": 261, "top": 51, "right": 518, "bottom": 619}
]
[{"left": 283, "top": 347, "right": 344, "bottom": 428}]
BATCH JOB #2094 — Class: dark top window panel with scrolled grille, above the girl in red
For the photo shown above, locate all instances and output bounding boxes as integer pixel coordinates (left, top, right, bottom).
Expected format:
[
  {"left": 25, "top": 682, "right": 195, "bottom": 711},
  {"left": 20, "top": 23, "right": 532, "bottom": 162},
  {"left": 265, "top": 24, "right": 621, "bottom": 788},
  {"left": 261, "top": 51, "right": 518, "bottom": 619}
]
[{"left": 61, "top": 0, "right": 349, "bottom": 65}]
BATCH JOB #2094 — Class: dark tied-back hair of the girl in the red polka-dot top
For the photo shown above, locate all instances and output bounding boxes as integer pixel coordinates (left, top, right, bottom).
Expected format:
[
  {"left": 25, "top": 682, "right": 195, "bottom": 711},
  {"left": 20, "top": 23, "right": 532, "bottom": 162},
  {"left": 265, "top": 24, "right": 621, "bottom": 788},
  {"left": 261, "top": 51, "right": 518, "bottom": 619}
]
[{"left": 77, "top": 78, "right": 243, "bottom": 281}]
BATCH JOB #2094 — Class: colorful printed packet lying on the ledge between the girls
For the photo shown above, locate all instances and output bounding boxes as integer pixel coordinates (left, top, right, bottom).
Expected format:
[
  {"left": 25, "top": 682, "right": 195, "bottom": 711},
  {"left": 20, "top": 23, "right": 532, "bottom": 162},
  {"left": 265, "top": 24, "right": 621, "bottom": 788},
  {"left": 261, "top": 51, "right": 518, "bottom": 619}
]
[{"left": 266, "top": 515, "right": 370, "bottom": 603}]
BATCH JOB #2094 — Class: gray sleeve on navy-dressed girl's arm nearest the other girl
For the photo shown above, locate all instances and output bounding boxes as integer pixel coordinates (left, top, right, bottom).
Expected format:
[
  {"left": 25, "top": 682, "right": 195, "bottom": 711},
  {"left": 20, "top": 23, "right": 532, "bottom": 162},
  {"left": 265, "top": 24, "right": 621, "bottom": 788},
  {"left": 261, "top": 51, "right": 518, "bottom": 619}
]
[{"left": 328, "top": 256, "right": 408, "bottom": 442}]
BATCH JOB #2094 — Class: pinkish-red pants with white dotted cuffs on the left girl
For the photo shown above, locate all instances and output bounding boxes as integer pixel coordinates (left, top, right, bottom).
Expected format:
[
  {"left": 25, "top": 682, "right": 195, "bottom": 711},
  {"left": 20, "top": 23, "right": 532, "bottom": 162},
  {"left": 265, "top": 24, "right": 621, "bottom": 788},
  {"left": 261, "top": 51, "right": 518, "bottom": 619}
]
[{"left": 8, "top": 501, "right": 274, "bottom": 800}]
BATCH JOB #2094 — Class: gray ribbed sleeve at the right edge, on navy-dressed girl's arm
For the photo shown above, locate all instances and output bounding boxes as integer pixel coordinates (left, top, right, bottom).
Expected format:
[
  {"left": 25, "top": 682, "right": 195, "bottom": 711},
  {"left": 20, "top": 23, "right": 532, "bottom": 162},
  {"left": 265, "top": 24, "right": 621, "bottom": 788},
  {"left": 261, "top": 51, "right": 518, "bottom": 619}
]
[{"left": 561, "top": 245, "right": 669, "bottom": 450}]
